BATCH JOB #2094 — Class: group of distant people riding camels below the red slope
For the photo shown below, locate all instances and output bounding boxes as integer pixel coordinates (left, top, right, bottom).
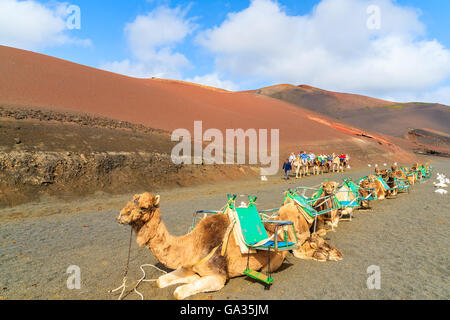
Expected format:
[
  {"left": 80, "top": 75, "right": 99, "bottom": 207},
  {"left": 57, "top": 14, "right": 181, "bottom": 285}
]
[{"left": 283, "top": 151, "right": 350, "bottom": 180}]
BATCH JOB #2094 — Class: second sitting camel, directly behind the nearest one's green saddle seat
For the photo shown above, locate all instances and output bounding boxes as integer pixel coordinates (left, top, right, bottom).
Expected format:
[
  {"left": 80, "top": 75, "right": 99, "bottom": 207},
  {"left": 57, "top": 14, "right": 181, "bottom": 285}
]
[{"left": 275, "top": 198, "right": 342, "bottom": 262}]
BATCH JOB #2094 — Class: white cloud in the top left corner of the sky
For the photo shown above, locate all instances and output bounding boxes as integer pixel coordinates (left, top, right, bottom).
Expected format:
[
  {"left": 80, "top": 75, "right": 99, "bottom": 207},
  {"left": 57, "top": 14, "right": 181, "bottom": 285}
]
[{"left": 0, "top": 0, "right": 91, "bottom": 50}]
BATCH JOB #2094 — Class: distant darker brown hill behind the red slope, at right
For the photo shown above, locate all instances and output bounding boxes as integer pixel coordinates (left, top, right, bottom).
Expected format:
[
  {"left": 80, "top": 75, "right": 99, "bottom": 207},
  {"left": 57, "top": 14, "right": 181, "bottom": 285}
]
[{"left": 253, "top": 85, "right": 450, "bottom": 138}]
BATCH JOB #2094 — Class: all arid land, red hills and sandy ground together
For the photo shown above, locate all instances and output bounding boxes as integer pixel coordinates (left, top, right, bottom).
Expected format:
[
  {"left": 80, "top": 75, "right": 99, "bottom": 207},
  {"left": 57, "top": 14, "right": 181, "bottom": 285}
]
[{"left": 0, "top": 46, "right": 450, "bottom": 300}]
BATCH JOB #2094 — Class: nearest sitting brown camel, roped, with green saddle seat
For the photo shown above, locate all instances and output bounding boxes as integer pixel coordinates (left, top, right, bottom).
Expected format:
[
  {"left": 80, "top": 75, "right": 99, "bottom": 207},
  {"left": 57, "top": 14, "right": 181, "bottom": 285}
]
[{"left": 117, "top": 192, "right": 287, "bottom": 300}]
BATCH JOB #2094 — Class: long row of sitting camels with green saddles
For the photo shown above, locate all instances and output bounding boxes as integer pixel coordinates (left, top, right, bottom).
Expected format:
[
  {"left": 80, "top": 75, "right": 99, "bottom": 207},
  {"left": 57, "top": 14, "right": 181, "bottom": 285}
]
[{"left": 117, "top": 164, "right": 432, "bottom": 299}]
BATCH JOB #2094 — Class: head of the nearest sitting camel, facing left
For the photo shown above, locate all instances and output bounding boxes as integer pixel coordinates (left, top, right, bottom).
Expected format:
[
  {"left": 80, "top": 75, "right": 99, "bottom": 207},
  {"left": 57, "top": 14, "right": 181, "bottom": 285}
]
[{"left": 117, "top": 192, "right": 160, "bottom": 225}]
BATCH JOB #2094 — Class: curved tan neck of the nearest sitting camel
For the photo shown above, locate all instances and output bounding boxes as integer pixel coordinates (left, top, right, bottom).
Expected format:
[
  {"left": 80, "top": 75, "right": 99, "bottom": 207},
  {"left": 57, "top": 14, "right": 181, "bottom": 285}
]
[{"left": 135, "top": 209, "right": 194, "bottom": 269}]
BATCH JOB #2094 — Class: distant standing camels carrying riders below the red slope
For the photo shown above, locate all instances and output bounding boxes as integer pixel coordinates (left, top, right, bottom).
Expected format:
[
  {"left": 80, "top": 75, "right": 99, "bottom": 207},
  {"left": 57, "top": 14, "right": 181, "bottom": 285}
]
[{"left": 292, "top": 155, "right": 348, "bottom": 179}]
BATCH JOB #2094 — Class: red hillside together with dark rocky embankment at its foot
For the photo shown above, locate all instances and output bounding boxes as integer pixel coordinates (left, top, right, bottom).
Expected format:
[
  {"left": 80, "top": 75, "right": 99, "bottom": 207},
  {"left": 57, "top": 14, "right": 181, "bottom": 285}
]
[{"left": 0, "top": 46, "right": 422, "bottom": 208}]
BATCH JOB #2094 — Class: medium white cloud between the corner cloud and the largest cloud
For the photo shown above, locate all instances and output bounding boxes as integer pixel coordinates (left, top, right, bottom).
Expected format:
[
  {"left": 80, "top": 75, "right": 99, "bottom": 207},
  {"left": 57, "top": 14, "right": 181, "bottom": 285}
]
[{"left": 101, "top": 7, "right": 196, "bottom": 78}]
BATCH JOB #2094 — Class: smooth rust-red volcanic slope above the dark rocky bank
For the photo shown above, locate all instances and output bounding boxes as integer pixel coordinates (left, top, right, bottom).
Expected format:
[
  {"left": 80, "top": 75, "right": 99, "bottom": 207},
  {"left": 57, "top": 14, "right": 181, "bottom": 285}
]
[{"left": 0, "top": 46, "right": 411, "bottom": 165}]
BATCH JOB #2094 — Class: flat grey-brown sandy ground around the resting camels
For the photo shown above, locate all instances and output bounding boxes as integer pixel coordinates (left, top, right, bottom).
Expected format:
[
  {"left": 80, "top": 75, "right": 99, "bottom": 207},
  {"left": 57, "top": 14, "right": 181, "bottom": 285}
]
[{"left": 0, "top": 158, "right": 450, "bottom": 300}]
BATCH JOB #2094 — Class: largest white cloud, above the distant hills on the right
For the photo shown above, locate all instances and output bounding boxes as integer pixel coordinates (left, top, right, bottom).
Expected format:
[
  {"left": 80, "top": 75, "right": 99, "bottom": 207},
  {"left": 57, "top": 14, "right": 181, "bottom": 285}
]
[{"left": 197, "top": 0, "right": 450, "bottom": 100}]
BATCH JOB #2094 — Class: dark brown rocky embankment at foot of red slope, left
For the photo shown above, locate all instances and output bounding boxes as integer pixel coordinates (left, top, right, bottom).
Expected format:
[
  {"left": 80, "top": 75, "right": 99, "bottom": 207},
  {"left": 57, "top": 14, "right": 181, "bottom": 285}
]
[{"left": 0, "top": 151, "right": 256, "bottom": 207}]
